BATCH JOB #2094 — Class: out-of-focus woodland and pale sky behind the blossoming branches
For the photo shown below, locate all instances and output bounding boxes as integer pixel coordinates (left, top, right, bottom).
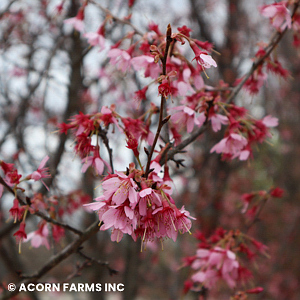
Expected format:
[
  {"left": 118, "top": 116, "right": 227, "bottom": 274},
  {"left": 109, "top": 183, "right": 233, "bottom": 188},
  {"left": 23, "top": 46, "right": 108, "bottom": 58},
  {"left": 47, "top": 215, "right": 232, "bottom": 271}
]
[{"left": 0, "top": 0, "right": 300, "bottom": 300}]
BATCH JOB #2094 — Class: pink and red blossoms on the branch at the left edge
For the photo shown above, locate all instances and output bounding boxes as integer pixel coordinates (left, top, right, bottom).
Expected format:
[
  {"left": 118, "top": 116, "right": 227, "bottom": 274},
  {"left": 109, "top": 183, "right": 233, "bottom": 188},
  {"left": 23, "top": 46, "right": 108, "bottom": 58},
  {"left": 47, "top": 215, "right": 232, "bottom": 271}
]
[{"left": 0, "top": 156, "right": 91, "bottom": 251}]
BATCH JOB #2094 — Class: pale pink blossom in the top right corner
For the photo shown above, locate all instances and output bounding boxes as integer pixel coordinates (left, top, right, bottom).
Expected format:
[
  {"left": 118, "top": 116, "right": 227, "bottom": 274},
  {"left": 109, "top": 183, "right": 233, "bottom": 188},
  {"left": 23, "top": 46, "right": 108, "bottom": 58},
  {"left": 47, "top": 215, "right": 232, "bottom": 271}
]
[{"left": 260, "top": 2, "right": 292, "bottom": 31}]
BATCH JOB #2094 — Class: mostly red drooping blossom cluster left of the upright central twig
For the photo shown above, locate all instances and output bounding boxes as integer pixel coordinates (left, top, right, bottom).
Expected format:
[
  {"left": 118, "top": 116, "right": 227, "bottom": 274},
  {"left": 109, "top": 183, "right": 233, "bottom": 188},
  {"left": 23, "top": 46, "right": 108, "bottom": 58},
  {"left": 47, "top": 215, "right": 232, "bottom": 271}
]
[{"left": 59, "top": 105, "right": 157, "bottom": 175}]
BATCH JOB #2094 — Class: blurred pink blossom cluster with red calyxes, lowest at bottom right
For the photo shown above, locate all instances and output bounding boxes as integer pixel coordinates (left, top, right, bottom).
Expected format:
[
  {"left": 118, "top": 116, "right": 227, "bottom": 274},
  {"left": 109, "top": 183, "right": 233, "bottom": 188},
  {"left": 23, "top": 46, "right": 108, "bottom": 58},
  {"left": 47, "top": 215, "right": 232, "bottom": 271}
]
[{"left": 185, "top": 228, "right": 267, "bottom": 294}]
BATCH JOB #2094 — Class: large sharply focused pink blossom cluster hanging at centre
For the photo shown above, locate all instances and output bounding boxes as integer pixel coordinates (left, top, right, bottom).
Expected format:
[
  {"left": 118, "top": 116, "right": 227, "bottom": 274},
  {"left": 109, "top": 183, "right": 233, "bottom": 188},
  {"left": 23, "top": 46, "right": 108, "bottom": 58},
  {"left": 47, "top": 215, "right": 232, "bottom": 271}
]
[{"left": 85, "top": 164, "right": 194, "bottom": 247}]
